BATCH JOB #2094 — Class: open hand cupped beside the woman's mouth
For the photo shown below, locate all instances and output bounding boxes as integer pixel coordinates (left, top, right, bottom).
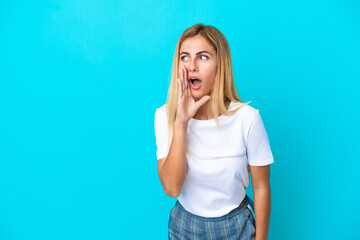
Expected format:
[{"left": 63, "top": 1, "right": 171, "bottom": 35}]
[{"left": 175, "top": 65, "right": 210, "bottom": 124}]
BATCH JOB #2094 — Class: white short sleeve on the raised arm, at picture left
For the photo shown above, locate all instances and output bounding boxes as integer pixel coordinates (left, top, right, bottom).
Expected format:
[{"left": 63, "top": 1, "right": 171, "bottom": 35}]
[{"left": 154, "top": 108, "right": 168, "bottom": 160}]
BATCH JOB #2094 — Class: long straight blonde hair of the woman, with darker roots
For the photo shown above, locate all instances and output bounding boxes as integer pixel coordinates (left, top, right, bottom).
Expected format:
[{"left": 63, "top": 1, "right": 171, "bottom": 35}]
[{"left": 166, "top": 23, "right": 252, "bottom": 158}]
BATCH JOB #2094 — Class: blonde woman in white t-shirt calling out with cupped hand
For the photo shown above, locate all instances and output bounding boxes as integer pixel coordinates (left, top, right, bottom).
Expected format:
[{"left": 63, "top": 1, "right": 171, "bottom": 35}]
[{"left": 155, "top": 24, "right": 274, "bottom": 240}]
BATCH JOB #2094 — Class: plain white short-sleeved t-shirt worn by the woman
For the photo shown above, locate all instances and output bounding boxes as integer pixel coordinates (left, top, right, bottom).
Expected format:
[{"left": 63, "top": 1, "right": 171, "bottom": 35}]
[{"left": 155, "top": 101, "right": 274, "bottom": 217}]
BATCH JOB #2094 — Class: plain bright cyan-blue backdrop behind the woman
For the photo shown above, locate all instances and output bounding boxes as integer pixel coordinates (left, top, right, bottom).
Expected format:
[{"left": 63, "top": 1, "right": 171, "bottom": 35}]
[{"left": 0, "top": 0, "right": 360, "bottom": 240}]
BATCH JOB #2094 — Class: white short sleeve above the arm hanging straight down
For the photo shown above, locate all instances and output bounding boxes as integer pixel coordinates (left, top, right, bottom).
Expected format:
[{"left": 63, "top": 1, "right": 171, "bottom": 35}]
[{"left": 246, "top": 109, "right": 274, "bottom": 166}]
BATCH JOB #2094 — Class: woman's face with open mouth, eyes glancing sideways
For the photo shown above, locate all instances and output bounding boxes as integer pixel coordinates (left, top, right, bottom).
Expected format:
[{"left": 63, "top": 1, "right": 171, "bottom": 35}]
[{"left": 179, "top": 35, "right": 217, "bottom": 100}]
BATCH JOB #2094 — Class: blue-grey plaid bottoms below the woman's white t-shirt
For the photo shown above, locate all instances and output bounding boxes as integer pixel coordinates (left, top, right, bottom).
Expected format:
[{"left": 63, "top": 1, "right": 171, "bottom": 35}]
[{"left": 168, "top": 195, "right": 255, "bottom": 240}]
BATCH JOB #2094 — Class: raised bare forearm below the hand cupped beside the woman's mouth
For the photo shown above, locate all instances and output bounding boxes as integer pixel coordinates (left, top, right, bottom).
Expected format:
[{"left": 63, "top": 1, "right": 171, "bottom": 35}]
[{"left": 161, "top": 121, "right": 187, "bottom": 197}]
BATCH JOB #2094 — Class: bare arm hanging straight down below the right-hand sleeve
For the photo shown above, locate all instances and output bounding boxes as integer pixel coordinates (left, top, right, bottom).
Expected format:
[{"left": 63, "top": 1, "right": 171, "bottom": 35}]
[{"left": 249, "top": 165, "right": 271, "bottom": 240}]
